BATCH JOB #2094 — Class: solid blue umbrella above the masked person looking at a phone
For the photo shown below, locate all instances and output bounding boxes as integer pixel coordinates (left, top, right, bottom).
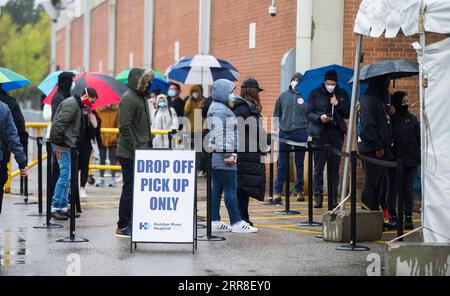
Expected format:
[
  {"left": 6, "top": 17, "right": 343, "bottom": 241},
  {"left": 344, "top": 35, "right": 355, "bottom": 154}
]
[{"left": 297, "top": 65, "right": 367, "bottom": 101}]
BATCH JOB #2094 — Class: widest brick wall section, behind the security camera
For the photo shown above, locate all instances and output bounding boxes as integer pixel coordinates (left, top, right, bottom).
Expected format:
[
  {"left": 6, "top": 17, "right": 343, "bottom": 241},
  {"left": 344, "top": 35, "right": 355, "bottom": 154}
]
[{"left": 211, "top": 0, "right": 297, "bottom": 117}]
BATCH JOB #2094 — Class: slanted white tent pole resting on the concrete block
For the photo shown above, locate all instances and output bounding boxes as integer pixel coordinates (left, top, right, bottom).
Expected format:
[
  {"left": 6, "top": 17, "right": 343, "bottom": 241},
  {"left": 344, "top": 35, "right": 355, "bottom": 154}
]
[{"left": 341, "top": 34, "right": 363, "bottom": 210}]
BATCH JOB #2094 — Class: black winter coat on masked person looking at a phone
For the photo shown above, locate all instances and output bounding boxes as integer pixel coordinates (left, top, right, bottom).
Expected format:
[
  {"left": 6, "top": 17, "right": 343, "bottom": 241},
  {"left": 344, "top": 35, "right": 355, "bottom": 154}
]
[{"left": 306, "top": 85, "right": 350, "bottom": 140}]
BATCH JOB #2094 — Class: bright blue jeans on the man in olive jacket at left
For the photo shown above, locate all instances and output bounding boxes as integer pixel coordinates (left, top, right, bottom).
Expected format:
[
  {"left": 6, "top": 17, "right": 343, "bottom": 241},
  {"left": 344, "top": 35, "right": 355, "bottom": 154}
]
[{"left": 52, "top": 152, "right": 71, "bottom": 211}]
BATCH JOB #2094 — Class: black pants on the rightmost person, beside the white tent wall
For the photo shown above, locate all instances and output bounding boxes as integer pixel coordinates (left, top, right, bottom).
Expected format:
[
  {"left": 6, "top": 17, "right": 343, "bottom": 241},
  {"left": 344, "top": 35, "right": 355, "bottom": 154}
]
[{"left": 387, "top": 167, "right": 417, "bottom": 216}]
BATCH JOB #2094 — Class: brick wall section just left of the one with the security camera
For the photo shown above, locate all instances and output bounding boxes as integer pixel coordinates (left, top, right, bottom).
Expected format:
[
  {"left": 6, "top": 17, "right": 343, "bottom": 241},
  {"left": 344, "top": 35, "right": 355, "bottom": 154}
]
[{"left": 153, "top": 0, "right": 199, "bottom": 96}]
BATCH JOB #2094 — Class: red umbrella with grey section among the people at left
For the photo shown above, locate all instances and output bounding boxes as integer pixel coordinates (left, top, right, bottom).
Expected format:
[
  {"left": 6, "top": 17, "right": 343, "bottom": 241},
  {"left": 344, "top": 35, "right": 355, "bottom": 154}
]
[{"left": 44, "top": 72, "right": 127, "bottom": 109}]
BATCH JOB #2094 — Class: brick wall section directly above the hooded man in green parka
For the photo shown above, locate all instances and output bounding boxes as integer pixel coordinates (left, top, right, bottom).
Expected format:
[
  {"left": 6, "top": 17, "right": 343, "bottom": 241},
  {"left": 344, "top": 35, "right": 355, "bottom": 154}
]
[{"left": 114, "top": 0, "right": 145, "bottom": 74}]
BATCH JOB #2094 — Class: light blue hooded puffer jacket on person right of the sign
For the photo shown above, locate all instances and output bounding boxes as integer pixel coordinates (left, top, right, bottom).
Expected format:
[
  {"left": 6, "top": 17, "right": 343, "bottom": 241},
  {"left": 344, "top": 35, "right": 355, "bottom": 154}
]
[{"left": 208, "top": 79, "right": 238, "bottom": 171}]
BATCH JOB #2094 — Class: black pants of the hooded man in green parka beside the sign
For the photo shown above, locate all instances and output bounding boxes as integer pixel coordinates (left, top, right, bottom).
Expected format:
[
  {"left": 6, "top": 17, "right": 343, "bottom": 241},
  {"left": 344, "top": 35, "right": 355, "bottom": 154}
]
[{"left": 117, "top": 157, "right": 134, "bottom": 229}]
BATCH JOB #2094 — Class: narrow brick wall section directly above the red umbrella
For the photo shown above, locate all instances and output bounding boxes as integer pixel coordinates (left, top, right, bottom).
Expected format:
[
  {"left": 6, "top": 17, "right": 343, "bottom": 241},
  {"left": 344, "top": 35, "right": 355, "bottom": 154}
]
[{"left": 90, "top": 1, "right": 109, "bottom": 73}]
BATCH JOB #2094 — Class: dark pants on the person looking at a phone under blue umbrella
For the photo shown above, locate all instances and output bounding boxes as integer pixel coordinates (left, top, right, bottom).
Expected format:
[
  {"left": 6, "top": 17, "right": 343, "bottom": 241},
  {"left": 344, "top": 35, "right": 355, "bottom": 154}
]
[{"left": 313, "top": 134, "right": 344, "bottom": 202}]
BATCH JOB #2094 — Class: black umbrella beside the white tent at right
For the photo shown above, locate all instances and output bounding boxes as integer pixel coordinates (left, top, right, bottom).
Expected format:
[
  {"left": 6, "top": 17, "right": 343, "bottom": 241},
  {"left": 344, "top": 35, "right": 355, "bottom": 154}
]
[{"left": 350, "top": 60, "right": 420, "bottom": 83}]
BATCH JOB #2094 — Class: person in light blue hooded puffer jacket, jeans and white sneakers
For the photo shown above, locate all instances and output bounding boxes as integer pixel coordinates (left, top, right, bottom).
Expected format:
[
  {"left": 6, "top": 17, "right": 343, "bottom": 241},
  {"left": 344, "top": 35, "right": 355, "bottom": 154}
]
[{"left": 208, "top": 79, "right": 258, "bottom": 233}]
